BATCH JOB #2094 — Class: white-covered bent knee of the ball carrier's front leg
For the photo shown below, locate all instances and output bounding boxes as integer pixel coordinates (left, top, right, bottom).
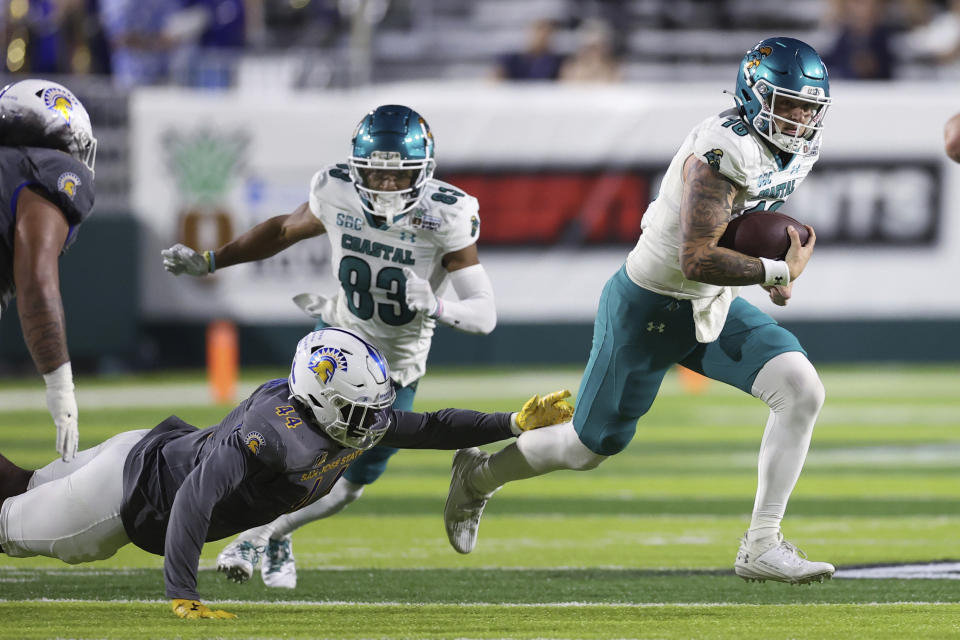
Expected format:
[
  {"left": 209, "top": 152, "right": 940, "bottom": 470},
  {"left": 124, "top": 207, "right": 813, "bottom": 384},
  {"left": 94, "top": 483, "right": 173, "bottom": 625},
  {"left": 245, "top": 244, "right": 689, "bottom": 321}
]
[{"left": 751, "top": 351, "right": 826, "bottom": 417}]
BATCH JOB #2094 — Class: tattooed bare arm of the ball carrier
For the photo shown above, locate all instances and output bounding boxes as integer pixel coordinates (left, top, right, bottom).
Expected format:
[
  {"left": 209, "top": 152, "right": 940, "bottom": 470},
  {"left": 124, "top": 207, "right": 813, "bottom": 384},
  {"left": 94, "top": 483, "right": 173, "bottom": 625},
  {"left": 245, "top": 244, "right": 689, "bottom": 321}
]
[{"left": 680, "top": 156, "right": 764, "bottom": 286}]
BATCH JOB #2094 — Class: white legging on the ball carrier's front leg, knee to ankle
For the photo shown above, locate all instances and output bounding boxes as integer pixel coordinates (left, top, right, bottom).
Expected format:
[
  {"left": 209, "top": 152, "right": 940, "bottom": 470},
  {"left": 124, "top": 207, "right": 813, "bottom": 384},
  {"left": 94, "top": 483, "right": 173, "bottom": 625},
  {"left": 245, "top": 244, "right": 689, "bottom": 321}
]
[{"left": 747, "top": 351, "right": 824, "bottom": 542}]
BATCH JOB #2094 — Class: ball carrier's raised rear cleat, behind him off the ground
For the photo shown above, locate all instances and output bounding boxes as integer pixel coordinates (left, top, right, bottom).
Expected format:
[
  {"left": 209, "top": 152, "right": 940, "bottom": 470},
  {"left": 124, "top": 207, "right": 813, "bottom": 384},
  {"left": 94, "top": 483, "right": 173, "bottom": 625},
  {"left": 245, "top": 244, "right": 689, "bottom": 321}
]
[{"left": 443, "top": 447, "right": 493, "bottom": 553}]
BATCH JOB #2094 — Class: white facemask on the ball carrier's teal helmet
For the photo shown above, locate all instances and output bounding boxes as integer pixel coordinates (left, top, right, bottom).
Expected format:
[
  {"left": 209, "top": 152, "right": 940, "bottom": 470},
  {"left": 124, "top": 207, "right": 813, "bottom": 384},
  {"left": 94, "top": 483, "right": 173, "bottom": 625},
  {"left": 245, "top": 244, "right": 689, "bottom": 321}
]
[{"left": 751, "top": 79, "right": 831, "bottom": 154}]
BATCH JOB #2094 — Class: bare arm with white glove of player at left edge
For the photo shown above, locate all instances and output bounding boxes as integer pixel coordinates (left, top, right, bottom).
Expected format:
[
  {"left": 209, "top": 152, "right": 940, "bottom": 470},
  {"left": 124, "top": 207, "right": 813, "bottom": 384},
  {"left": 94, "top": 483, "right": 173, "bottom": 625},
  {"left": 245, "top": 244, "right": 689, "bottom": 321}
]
[{"left": 13, "top": 188, "right": 79, "bottom": 461}]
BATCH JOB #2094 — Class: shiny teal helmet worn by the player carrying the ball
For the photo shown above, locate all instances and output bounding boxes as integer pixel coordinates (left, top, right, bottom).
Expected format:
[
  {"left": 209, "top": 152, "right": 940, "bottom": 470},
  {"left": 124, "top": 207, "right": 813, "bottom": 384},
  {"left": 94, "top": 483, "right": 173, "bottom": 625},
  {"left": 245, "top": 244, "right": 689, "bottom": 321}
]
[{"left": 734, "top": 37, "right": 830, "bottom": 155}]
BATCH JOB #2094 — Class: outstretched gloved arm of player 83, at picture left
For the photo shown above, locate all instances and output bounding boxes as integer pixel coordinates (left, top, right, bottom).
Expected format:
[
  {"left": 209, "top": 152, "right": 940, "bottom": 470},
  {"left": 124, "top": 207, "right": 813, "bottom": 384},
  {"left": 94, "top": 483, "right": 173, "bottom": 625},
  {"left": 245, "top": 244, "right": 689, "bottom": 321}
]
[{"left": 160, "top": 202, "right": 326, "bottom": 276}]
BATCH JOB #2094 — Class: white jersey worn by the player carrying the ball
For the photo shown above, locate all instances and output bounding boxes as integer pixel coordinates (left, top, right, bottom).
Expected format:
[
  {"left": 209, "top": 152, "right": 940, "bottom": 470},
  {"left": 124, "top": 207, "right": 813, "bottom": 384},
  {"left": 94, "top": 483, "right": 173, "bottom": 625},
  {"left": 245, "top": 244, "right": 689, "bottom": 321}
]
[{"left": 627, "top": 109, "right": 820, "bottom": 298}]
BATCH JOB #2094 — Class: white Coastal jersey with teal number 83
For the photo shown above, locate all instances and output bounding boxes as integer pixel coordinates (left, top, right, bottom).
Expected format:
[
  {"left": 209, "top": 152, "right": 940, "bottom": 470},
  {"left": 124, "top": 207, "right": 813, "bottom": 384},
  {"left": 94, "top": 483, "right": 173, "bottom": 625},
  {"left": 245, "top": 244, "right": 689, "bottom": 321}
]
[{"left": 310, "top": 164, "right": 480, "bottom": 386}]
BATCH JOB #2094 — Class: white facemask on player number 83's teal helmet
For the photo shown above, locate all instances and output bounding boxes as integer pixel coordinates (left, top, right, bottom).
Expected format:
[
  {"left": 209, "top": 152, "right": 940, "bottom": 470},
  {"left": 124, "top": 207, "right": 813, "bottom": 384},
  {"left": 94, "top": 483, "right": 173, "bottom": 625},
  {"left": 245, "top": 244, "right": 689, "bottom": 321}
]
[{"left": 349, "top": 151, "right": 435, "bottom": 225}]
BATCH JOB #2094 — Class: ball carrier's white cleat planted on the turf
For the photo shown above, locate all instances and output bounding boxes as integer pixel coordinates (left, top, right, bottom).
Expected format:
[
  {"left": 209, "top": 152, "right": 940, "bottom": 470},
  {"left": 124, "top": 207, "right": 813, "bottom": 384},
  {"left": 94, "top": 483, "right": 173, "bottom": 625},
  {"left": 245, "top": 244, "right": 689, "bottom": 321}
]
[{"left": 733, "top": 532, "right": 836, "bottom": 584}]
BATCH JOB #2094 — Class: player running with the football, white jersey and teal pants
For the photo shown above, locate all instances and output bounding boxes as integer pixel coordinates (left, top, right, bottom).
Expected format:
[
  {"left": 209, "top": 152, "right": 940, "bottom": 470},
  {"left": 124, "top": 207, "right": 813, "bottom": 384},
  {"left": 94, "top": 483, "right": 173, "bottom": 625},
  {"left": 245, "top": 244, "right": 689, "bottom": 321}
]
[{"left": 444, "top": 37, "right": 834, "bottom": 584}]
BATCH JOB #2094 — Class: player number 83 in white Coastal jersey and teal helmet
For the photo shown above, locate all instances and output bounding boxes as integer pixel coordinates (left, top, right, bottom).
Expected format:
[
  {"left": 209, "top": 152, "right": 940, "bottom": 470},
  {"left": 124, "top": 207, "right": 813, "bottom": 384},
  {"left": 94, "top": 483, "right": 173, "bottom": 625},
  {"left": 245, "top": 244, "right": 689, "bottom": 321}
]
[{"left": 163, "top": 105, "right": 497, "bottom": 588}]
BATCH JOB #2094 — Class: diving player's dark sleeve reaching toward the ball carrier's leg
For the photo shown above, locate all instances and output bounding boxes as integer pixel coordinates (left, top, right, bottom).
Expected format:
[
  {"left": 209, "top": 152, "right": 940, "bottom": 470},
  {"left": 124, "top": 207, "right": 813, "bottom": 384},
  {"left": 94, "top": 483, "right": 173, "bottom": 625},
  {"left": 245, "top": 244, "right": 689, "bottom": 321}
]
[{"left": 380, "top": 409, "right": 513, "bottom": 449}]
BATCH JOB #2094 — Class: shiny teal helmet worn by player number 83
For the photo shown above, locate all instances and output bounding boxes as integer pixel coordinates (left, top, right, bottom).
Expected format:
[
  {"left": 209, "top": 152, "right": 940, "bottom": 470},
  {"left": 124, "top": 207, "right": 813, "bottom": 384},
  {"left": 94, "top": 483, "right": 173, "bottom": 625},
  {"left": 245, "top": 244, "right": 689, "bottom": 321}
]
[{"left": 348, "top": 104, "right": 436, "bottom": 225}]
